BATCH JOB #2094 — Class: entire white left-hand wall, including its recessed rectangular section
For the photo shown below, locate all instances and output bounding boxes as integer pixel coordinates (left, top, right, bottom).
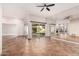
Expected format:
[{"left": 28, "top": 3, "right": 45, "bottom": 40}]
[{"left": 2, "top": 18, "right": 24, "bottom": 36}]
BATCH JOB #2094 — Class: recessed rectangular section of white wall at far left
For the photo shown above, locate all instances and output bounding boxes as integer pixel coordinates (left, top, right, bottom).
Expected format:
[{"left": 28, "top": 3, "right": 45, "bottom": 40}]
[{"left": 2, "top": 23, "right": 17, "bottom": 35}]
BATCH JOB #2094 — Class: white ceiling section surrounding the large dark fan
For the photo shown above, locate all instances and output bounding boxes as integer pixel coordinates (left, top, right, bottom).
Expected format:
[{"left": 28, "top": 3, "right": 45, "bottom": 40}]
[{"left": 2, "top": 3, "right": 79, "bottom": 18}]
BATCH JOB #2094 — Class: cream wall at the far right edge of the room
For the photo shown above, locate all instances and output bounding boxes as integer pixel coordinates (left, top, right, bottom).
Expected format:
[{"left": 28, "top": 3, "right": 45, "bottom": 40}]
[{"left": 68, "top": 20, "right": 79, "bottom": 36}]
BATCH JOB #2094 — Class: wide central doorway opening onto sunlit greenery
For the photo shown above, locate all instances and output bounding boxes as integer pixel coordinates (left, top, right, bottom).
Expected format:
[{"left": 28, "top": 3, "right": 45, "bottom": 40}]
[{"left": 32, "top": 22, "right": 45, "bottom": 37}]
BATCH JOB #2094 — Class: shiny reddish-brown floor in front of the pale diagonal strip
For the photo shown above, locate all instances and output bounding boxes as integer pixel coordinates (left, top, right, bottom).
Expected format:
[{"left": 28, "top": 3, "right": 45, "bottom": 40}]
[{"left": 2, "top": 36, "right": 79, "bottom": 56}]
